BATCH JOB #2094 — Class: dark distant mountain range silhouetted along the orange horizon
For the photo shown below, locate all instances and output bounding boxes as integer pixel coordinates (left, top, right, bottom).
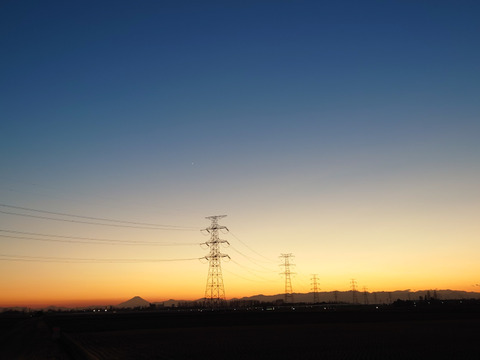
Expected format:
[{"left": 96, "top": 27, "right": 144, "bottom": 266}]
[{"left": 0, "top": 290, "right": 480, "bottom": 312}]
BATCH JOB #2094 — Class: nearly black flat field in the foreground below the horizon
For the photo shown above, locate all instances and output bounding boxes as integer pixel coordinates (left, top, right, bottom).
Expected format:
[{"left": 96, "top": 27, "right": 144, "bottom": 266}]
[{"left": 0, "top": 309, "right": 480, "bottom": 360}]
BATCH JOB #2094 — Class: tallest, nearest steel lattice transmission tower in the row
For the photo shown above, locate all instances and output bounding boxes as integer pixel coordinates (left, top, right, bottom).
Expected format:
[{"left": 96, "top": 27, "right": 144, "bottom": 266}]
[{"left": 203, "top": 215, "right": 230, "bottom": 307}]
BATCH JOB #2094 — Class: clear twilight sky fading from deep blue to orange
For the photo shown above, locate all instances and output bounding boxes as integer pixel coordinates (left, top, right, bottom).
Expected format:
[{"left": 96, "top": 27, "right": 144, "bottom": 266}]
[{"left": 0, "top": 0, "right": 480, "bottom": 306}]
